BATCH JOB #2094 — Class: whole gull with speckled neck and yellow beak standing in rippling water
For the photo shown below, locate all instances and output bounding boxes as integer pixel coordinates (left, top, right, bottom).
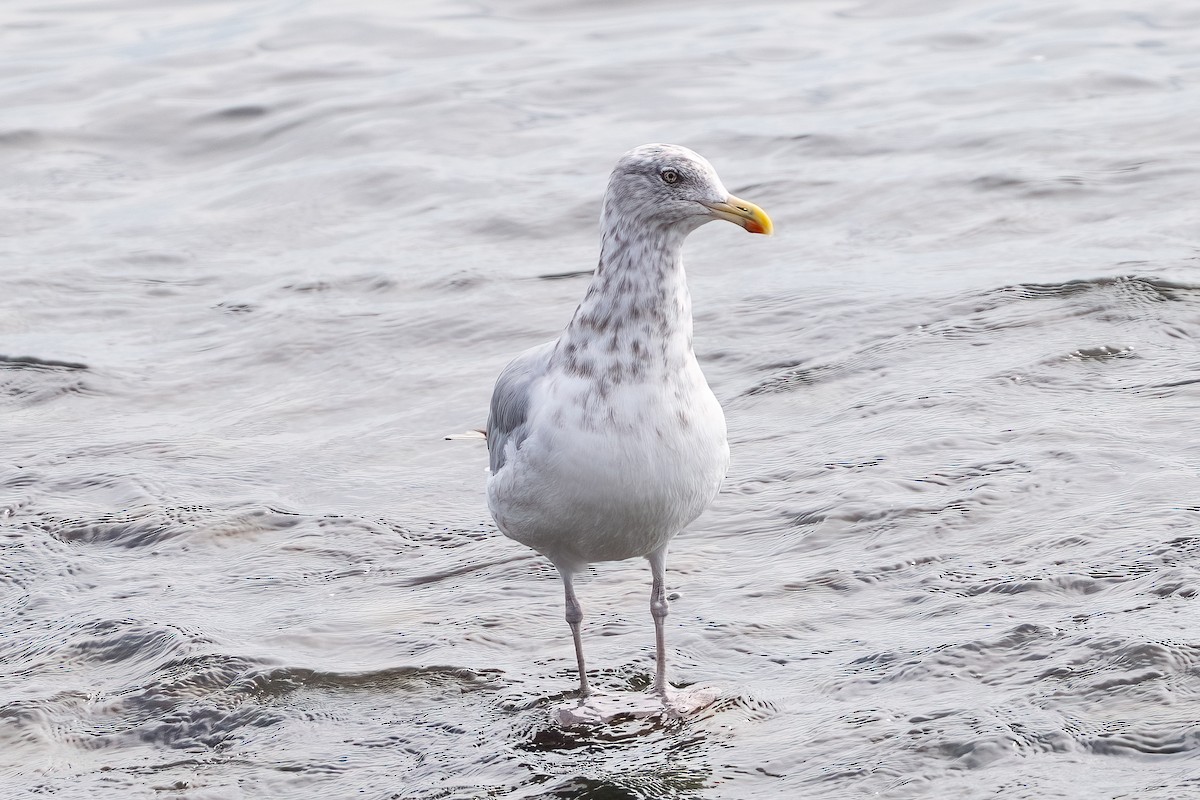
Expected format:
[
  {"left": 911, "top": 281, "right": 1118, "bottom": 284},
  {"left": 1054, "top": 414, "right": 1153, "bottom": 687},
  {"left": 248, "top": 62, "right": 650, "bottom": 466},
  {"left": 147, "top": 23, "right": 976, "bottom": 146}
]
[{"left": 486, "top": 144, "right": 773, "bottom": 702}]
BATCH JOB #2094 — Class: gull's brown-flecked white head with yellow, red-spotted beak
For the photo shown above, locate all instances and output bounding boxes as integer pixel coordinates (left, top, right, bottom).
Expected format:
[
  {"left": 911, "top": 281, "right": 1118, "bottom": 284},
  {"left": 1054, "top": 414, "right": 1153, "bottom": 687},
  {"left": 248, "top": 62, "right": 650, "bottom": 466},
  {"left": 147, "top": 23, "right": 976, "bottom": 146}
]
[{"left": 604, "top": 144, "right": 774, "bottom": 235}]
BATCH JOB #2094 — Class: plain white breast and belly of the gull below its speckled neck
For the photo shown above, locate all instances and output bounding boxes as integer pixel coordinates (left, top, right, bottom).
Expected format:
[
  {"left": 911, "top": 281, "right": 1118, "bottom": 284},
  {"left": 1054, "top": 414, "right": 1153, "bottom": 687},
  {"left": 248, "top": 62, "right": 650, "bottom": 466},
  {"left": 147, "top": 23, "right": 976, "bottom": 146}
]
[{"left": 487, "top": 360, "right": 728, "bottom": 570}]
